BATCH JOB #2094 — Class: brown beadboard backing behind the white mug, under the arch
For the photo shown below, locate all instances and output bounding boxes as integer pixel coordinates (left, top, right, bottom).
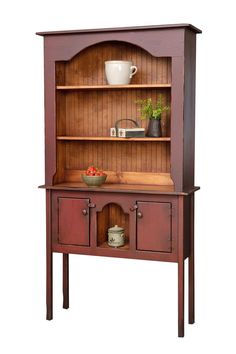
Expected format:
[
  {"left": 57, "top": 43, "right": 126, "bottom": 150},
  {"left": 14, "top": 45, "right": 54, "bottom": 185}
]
[{"left": 56, "top": 40, "right": 171, "bottom": 85}]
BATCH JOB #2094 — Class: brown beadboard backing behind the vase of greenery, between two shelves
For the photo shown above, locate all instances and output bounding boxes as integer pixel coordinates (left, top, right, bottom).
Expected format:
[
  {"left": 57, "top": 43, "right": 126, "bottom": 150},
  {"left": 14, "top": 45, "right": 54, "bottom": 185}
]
[{"left": 57, "top": 89, "right": 171, "bottom": 137}]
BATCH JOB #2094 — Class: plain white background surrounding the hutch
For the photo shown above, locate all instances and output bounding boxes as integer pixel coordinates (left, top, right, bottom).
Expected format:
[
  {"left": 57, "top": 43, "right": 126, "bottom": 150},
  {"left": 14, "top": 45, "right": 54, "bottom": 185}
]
[{"left": 0, "top": 0, "right": 236, "bottom": 354}]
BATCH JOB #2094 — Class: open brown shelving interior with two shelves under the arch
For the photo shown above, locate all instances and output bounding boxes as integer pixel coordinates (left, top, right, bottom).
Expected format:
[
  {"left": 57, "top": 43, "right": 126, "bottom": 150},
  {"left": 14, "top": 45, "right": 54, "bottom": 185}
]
[{"left": 54, "top": 41, "right": 173, "bottom": 185}]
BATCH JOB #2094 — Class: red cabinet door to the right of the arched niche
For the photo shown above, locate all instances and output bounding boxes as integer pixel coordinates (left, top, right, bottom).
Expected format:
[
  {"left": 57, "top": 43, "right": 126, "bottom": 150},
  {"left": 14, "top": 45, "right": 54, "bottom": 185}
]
[{"left": 137, "top": 202, "right": 171, "bottom": 252}]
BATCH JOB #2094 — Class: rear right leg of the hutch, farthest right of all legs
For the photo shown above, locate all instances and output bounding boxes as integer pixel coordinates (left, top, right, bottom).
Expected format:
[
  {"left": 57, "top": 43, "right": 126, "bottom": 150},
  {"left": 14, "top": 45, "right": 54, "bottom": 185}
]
[{"left": 188, "top": 194, "right": 195, "bottom": 324}]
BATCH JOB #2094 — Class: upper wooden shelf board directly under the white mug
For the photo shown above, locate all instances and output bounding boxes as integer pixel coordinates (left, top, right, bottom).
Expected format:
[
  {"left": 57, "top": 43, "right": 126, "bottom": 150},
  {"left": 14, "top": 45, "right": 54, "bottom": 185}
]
[{"left": 56, "top": 84, "right": 171, "bottom": 90}]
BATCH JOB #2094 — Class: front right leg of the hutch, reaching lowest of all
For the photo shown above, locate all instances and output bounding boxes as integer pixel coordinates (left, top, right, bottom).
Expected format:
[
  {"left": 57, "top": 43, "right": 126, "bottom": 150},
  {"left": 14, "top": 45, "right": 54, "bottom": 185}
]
[{"left": 178, "top": 196, "right": 184, "bottom": 337}]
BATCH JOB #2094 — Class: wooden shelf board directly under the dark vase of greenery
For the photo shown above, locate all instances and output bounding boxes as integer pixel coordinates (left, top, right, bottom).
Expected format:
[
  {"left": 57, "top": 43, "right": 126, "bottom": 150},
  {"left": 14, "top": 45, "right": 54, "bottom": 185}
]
[{"left": 57, "top": 136, "right": 170, "bottom": 142}]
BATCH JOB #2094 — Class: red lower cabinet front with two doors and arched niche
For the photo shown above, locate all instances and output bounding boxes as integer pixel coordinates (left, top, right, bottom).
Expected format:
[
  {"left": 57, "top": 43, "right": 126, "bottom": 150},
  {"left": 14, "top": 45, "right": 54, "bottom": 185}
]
[{"left": 52, "top": 192, "right": 176, "bottom": 259}]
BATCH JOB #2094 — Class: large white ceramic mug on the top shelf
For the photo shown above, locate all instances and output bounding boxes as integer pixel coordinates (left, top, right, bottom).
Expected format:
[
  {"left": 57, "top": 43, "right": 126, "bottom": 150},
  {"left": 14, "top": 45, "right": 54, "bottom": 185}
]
[{"left": 105, "top": 60, "right": 138, "bottom": 85}]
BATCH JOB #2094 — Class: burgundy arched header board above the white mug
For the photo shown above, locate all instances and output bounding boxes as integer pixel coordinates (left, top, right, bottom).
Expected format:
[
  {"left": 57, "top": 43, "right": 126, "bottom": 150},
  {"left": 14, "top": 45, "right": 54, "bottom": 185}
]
[{"left": 44, "top": 29, "right": 185, "bottom": 62}]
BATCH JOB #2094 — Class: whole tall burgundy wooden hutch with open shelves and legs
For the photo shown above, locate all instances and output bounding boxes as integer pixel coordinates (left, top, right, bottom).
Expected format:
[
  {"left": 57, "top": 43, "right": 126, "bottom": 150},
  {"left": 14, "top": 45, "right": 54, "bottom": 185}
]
[{"left": 37, "top": 24, "right": 201, "bottom": 337}]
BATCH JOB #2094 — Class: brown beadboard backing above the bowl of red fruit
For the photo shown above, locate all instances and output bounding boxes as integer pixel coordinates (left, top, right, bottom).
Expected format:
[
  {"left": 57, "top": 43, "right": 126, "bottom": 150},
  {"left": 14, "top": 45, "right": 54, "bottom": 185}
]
[{"left": 65, "top": 141, "right": 170, "bottom": 173}]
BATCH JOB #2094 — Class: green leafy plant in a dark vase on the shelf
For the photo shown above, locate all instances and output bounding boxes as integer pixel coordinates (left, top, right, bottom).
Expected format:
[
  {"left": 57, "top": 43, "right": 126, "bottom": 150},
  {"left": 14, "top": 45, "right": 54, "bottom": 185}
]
[{"left": 136, "top": 95, "right": 170, "bottom": 138}]
